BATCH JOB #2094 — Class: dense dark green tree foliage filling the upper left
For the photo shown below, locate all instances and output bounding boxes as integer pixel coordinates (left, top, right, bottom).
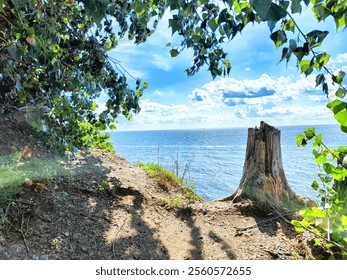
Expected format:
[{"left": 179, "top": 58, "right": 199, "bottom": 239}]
[{"left": 0, "top": 0, "right": 155, "bottom": 149}]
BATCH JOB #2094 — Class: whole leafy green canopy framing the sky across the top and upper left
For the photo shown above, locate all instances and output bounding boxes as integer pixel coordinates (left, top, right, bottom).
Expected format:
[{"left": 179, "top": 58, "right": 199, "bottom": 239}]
[{"left": 0, "top": 0, "right": 347, "bottom": 151}]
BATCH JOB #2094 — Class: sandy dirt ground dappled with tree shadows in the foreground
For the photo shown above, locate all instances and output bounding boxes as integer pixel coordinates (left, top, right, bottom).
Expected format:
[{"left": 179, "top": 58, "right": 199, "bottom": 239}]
[{"left": 0, "top": 148, "right": 316, "bottom": 259}]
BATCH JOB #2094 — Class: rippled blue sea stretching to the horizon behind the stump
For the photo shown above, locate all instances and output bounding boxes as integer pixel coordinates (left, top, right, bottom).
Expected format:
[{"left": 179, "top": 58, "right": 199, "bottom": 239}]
[{"left": 111, "top": 125, "right": 347, "bottom": 200}]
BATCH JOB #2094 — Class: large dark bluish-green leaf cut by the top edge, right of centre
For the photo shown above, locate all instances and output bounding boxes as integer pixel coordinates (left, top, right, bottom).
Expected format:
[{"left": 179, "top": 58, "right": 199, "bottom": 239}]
[{"left": 250, "top": 0, "right": 287, "bottom": 21}]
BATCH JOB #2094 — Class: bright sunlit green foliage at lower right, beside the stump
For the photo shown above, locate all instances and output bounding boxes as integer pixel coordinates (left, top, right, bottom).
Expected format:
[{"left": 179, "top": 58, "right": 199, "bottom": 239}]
[{"left": 292, "top": 127, "right": 347, "bottom": 256}]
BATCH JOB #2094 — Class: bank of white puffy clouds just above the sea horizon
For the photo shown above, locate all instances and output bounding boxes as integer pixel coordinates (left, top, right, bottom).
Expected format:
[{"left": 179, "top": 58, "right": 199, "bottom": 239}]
[{"left": 117, "top": 74, "right": 334, "bottom": 129}]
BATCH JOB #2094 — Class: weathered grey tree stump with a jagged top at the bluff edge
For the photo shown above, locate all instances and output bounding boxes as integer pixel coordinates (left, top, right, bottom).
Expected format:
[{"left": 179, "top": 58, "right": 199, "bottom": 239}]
[{"left": 224, "top": 122, "right": 308, "bottom": 210}]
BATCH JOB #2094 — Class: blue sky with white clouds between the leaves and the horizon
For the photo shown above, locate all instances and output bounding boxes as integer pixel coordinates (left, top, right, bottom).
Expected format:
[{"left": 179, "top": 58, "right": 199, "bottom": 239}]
[{"left": 99, "top": 4, "right": 347, "bottom": 131}]
